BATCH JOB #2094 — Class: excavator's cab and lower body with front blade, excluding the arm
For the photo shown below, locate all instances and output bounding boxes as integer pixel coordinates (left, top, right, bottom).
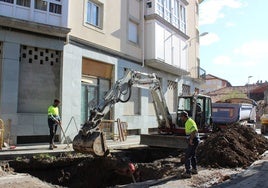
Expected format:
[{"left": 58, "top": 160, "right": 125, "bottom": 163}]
[{"left": 140, "top": 94, "right": 212, "bottom": 149}]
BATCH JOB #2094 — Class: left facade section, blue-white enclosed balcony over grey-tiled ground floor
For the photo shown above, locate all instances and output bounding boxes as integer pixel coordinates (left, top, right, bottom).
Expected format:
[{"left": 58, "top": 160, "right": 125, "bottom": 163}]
[{"left": 0, "top": 0, "right": 70, "bottom": 144}]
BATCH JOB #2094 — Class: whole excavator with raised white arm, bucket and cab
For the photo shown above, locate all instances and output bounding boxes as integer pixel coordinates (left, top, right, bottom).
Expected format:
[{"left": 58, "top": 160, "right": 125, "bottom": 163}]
[{"left": 73, "top": 70, "right": 211, "bottom": 157}]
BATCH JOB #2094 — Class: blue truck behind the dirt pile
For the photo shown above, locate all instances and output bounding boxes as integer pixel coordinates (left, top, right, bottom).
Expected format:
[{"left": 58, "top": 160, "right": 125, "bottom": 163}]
[{"left": 212, "top": 98, "right": 257, "bottom": 130}]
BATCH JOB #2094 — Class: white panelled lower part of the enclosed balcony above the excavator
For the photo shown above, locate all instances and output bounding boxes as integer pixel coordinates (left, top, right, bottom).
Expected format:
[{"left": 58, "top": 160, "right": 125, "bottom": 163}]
[{"left": 144, "top": 19, "right": 189, "bottom": 76}]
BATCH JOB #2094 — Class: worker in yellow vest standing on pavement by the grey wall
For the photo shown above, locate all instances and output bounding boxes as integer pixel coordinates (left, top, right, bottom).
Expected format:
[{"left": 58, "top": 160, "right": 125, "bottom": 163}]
[{"left": 48, "top": 99, "right": 61, "bottom": 150}]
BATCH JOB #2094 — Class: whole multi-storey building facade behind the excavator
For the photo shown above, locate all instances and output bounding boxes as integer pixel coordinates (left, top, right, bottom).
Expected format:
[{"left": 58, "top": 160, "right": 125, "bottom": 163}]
[{"left": 0, "top": 0, "right": 205, "bottom": 144}]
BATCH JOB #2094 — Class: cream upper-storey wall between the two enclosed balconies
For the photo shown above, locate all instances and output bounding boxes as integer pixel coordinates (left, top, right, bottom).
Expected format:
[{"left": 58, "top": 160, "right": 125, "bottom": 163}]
[{"left": 68, "top": 0, "right": 143, "bottom": 61}]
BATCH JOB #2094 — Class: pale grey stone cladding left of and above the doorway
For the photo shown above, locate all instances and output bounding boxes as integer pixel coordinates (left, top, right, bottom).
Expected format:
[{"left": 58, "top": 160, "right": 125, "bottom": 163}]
[{"left": 62, "top": 44, "right": 117, "bottom": 139}]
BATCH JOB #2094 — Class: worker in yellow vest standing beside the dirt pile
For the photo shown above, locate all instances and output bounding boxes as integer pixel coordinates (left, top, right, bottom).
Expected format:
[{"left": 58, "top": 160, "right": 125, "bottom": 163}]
[{"left": 180, "top": 111, "right": 199, "bottom": 178}]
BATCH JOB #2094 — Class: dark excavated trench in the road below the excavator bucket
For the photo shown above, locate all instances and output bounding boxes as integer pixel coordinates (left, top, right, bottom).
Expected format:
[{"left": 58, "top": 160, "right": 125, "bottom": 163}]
[{"left": 9, "top": 148, "right": 183, "bottom": 187}]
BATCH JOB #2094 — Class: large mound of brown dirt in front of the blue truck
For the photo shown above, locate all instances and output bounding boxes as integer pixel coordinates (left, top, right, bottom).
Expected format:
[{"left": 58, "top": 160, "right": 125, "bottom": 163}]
[{"left": 197, "top": 125, "right": 268, "bottom": 168}]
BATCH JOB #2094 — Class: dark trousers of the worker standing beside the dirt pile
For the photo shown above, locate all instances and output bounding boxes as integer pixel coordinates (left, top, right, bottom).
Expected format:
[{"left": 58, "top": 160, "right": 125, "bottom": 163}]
[{"left": 185, "top": 137, "right": 199, "bottom": 173}]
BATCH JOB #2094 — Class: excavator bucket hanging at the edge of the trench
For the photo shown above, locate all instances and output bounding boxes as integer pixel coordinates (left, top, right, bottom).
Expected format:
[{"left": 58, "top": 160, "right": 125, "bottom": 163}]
[{"left": 73, "top": 131, "right": 109, "bottom": 157}]
